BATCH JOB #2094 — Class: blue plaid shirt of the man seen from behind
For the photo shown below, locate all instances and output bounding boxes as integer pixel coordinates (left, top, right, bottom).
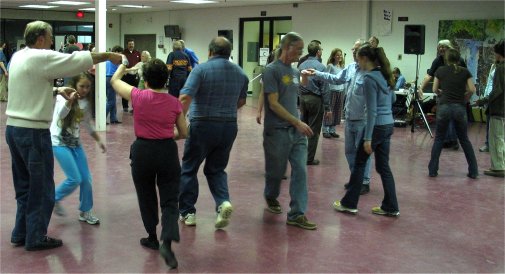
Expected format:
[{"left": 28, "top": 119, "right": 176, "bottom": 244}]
[{"left": 180, "top": 56, "right": 249, "bottom": 118}]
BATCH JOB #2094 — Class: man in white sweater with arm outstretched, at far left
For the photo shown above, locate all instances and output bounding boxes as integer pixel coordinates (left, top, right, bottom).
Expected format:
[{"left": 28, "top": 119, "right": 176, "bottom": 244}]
[{"left": 5, "top": 21, "right": 121, "bottom": 251}]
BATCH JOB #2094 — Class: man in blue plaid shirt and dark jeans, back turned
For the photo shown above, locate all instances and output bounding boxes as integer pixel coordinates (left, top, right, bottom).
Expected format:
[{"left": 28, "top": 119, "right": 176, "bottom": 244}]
[{"left": 179, "top": 37, "right": 249, "bottom": 229}]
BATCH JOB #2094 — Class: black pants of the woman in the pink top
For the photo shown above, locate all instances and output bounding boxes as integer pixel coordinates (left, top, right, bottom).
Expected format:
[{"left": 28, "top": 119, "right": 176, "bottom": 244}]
[{"left": 130, "top": 138, "right": 181, "bottom": 242}]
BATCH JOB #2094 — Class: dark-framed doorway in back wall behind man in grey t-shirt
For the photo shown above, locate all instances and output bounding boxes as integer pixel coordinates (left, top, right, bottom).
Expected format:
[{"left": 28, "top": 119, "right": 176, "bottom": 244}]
[{"left": 238, "top": 16, "right": 292, "bottom": 97}]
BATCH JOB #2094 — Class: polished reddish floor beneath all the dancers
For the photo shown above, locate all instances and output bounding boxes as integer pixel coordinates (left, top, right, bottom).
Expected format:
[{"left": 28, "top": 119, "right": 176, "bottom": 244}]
[{"left": 0, "top": 97, "right": 505, "bottom": 273}]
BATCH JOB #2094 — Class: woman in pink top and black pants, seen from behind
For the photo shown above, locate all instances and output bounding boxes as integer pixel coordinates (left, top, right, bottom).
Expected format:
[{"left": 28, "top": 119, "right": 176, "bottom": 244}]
[{"left": 110, "top": 59, "right": 188, "bottom": 268}]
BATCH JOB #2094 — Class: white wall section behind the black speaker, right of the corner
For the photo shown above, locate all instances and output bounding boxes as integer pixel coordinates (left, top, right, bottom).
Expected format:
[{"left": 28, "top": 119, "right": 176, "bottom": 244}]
[{"left": 370, "top": 1, "right": 505, "bottom": 83}]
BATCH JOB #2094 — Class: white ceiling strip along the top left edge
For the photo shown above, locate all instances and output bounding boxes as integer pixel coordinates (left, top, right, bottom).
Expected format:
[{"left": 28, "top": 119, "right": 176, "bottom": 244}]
[{"left": 0, "top": 0, "right": 343, "bottom": 13}]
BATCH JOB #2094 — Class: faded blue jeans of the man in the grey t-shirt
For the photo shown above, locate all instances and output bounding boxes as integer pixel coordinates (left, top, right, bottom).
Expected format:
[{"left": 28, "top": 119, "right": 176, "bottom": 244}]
[{"left": 263, "top": 127, "right": 308, "bottom": 220}]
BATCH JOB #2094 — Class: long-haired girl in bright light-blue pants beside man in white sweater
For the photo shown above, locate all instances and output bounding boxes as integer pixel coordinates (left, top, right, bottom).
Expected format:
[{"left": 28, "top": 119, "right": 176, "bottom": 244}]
[{"left": 50, "top": 72, "right": 106, "bottom": 225}]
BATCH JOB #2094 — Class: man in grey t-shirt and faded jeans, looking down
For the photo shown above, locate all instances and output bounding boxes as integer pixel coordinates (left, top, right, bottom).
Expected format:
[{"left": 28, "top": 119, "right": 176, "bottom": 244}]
[{"left": 263, "top": 32, "right": 317, "bottom": 230}]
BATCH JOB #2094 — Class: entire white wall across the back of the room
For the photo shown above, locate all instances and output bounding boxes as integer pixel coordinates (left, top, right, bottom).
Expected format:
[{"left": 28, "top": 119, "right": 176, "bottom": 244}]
[{"left": 0, "top": 0, "right": 504, "bottom": 81}]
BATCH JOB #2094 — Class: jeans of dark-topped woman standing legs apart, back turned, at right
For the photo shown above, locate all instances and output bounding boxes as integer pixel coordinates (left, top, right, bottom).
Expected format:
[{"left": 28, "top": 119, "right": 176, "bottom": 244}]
[{"left": 428, "top": 104, "right": 479, "bottom": 176}]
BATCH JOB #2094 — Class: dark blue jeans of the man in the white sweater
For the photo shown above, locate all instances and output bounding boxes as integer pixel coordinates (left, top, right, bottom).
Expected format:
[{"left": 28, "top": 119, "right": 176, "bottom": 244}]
[{"left": 5, "top": 126, "right": 54, "bottom": 246}]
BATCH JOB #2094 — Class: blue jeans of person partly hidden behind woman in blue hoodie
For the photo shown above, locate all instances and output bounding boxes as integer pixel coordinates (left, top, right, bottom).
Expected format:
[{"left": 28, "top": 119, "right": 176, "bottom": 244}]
[{"left": 344, "top": 120, "right": 372, "bottom": 184}]
